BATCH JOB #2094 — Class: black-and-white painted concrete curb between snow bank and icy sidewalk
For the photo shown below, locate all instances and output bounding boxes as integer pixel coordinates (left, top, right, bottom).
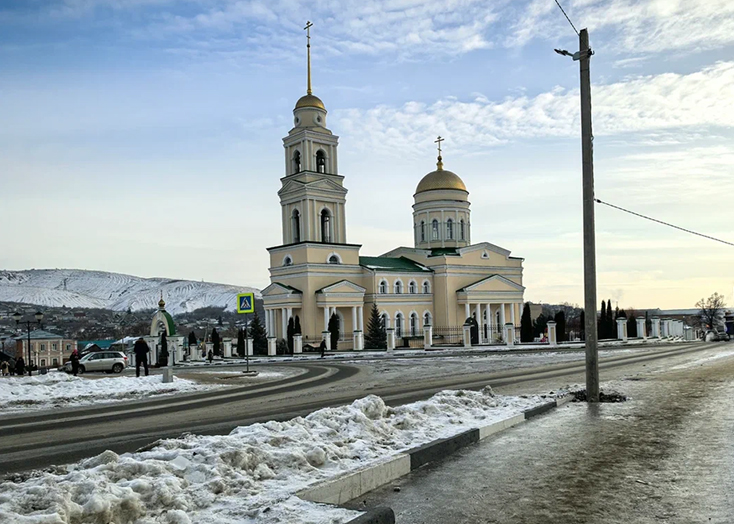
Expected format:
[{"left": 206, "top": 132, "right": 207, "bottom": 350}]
[{"left": 296, "top": 395, "right": 573, "bottom": 524}]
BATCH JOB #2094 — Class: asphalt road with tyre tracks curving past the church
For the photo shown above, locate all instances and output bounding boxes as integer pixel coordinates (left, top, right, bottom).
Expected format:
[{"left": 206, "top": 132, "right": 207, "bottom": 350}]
[{"left": 0, "top": 344, "right": 706, "bottom": 475}]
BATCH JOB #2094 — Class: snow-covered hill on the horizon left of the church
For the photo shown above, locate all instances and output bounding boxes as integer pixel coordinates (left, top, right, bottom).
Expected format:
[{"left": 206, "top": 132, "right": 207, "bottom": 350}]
[{"left": 0, "top": 269, "right": 260, "bottom": 315}]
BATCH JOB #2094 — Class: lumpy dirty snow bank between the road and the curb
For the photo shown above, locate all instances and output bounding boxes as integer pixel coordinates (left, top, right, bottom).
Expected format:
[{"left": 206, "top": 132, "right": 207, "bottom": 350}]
[{"left": 0, "top": 388, "right": 547, "bottom": 524}]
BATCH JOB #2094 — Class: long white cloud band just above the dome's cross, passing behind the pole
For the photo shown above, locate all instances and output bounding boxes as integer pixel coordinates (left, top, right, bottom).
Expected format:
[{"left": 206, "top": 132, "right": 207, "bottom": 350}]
[{"left": 335, "top": 62, "right": 734, "bottom": 154}]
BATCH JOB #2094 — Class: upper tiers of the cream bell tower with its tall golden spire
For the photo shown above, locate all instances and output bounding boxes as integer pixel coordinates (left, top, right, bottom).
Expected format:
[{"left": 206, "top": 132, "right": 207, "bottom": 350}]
[{"left": 278, "top": 22, "right": 347, "bottom": 245}]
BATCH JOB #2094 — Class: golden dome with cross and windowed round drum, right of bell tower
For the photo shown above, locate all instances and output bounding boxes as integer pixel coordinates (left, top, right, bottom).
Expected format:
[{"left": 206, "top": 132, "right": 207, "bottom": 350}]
[{"left": 413, "top": 136, "right": 471, "bottom": 249}]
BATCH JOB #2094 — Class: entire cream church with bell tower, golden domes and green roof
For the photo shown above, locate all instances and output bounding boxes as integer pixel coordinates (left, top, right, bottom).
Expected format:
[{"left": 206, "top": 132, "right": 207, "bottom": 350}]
[{"left": 262, "top": 23, "right": 525, "bottom": 350}]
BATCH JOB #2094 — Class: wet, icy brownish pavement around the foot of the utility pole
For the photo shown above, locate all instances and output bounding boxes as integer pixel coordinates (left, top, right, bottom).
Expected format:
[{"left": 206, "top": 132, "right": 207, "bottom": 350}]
[{"left": 351, "top": 344, "right": 734, "bottom": 524}]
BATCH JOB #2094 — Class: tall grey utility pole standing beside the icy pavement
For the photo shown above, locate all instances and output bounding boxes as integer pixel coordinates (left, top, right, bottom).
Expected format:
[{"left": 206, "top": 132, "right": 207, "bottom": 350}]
[{"left": 579, "top": 29, "right": 599, "bottom": 402}]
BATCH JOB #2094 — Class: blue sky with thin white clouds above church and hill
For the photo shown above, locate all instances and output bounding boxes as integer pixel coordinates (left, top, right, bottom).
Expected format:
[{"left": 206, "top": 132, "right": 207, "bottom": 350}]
[{"left": 0, "top": 0, "right": 734, "bottom": 308}]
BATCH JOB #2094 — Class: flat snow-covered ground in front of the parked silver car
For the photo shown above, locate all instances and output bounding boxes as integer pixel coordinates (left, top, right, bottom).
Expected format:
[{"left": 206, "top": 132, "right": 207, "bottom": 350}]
[{"left": 0, "top": 372, "right": 224, "bottom": 413}]
